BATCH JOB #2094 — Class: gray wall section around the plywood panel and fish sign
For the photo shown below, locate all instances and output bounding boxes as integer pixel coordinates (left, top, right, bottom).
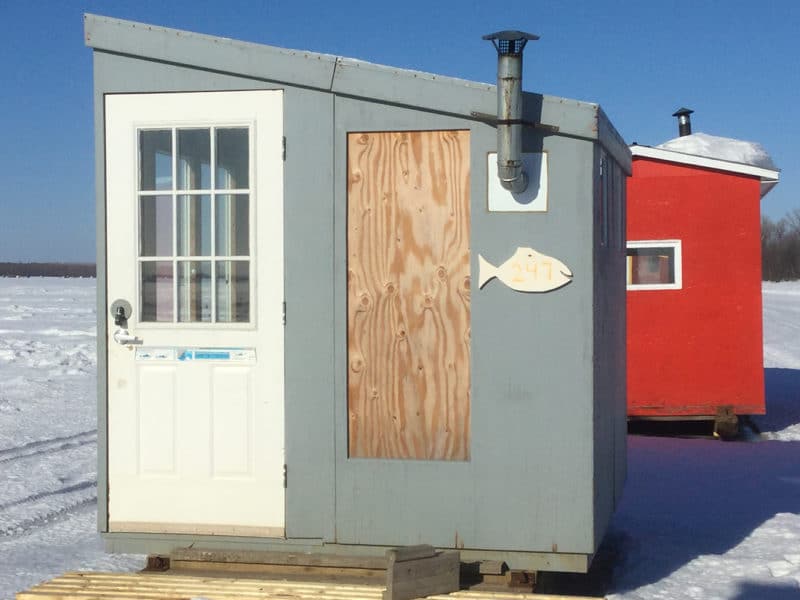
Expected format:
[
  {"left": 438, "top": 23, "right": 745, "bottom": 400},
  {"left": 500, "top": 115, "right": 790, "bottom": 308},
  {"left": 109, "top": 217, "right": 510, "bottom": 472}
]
[{"left": 334, "top": 98, "right": 593, "bottom": 552}]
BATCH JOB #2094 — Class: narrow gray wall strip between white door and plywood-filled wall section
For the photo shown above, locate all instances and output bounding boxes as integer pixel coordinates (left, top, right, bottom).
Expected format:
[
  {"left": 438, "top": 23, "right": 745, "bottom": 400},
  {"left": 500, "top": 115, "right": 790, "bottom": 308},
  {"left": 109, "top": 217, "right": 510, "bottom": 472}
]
[{"left": 284, "top": 88, "right": 335, "bottom": 541}]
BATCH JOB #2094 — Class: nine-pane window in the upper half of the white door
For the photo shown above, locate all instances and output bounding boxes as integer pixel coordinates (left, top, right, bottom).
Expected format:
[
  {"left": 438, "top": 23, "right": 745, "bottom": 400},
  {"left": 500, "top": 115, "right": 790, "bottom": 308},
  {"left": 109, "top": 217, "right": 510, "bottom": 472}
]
[{"left": 138, "top": 127, "right": 252, "bottom": 323}]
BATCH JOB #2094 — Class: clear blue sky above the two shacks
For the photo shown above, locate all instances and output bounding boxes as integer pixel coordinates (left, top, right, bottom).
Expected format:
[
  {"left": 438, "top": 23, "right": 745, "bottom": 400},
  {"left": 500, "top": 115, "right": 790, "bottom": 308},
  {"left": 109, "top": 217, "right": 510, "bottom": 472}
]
[{"left": 0, "top": 0, "right": 800, "bottom": 261}]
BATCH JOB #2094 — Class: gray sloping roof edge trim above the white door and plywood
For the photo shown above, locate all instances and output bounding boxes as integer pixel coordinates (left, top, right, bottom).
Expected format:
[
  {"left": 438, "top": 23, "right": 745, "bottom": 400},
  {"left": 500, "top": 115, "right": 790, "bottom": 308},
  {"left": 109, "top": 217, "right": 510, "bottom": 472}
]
[{"left": 84, "top": 13, "right": 612, "bottom": 142}]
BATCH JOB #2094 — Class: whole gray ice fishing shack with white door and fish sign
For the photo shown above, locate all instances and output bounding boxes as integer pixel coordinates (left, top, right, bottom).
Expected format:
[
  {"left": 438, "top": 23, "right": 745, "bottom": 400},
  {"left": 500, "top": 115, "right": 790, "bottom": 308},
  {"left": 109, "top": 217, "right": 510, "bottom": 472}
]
[{"left": 85, "top": 15, "right": 630, "bottom": 571}]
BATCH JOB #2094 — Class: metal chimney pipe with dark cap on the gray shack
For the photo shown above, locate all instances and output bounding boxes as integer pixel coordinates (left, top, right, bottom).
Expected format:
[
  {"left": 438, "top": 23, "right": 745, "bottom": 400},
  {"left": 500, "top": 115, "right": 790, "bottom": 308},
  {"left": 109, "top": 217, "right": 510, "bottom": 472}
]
[{"left": 483, "top": 31, "right": 539, "bottom": 194}]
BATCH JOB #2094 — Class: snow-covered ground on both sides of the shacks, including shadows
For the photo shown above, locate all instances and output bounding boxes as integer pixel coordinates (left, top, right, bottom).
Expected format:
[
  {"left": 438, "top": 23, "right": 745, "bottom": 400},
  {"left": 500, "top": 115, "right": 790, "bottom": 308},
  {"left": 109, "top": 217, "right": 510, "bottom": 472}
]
[{"left": 0, "top": 278, "right": 800, "bottom": 600}]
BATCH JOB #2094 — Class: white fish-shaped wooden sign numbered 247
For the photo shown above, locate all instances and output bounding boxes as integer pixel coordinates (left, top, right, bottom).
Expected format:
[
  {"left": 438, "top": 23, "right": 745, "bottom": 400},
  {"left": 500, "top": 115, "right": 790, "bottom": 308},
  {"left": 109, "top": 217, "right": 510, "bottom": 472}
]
[{"left": 478, "top": 248, "right": 572, "bottom": 292}]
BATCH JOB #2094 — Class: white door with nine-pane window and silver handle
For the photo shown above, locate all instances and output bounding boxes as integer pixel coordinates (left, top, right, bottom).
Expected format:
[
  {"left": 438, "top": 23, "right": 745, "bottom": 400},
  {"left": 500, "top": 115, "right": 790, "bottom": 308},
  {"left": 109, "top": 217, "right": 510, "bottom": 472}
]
[{"left": 105, "top": 91, "right": 284, "bottom": 537}]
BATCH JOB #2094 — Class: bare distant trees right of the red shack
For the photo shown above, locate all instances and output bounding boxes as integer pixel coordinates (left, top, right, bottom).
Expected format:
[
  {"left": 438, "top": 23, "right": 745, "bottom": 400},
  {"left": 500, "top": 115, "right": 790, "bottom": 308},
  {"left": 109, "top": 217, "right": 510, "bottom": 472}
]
[{"left": 761, "top": 208, "right": 800, "bottom": 281}]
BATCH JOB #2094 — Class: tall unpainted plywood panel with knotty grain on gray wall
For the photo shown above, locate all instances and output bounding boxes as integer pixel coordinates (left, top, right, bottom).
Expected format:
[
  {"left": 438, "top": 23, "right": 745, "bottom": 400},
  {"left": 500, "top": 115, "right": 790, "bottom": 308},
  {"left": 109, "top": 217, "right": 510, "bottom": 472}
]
[{"left": 347, "top": 131, "right": 470, "bottom": 460}]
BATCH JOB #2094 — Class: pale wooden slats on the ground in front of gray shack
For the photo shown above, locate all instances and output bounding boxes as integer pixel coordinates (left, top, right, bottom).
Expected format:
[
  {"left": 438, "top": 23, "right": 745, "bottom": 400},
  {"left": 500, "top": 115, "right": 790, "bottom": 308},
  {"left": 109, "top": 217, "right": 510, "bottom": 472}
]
[{"left": 17, "top": 573, "right": 600, "bottom": 600}]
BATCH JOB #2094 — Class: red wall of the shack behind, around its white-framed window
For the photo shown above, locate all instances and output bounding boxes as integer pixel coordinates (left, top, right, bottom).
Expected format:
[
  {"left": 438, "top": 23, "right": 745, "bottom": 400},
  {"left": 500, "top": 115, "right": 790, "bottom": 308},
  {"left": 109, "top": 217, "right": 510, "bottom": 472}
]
[{"left": 627, "top": 158, "right": 764, "bottom": 416}]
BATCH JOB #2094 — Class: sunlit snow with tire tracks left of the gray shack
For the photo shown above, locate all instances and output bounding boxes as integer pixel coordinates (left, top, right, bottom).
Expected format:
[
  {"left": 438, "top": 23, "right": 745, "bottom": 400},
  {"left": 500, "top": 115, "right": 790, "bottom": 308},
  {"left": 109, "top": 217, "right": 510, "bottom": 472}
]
[{"left": 0, "top": 277, "right": 143, "bottom": 600}]
